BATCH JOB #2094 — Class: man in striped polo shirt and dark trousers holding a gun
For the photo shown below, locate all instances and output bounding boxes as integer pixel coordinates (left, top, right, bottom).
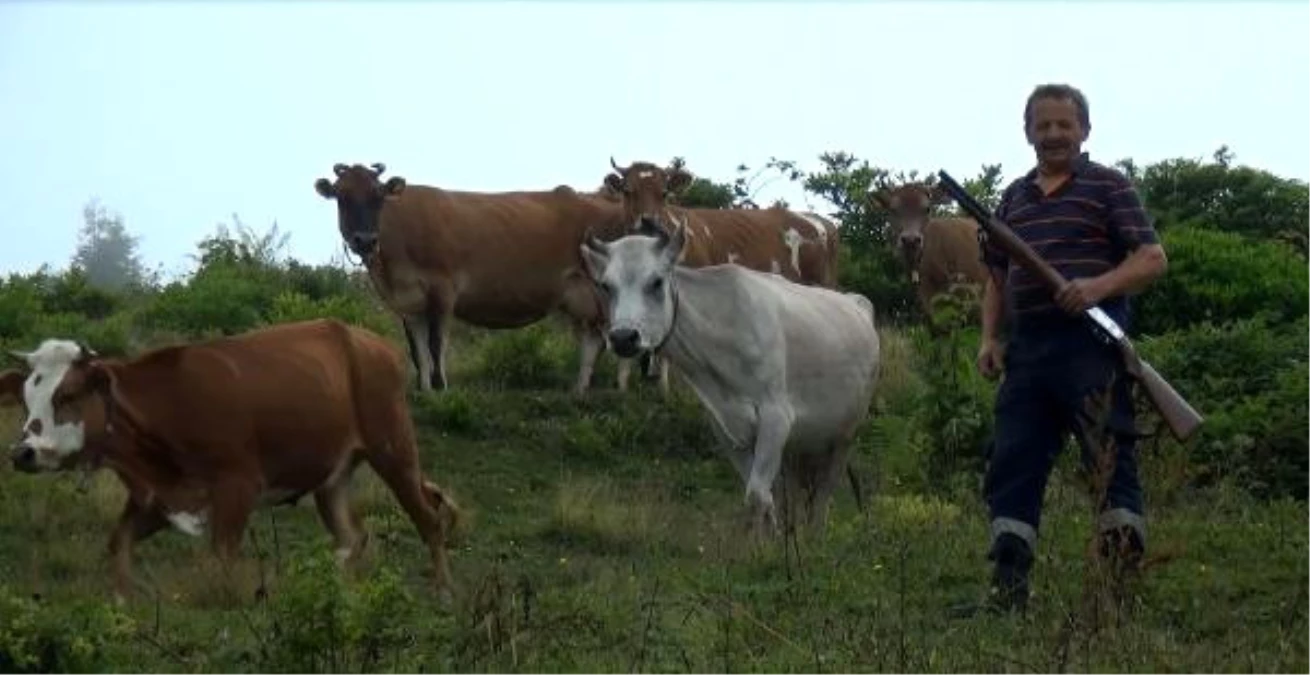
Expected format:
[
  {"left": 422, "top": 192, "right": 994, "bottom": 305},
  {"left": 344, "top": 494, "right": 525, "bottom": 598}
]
[{"left": 977, "top": 84, "right": 1167, "bottom": 609}]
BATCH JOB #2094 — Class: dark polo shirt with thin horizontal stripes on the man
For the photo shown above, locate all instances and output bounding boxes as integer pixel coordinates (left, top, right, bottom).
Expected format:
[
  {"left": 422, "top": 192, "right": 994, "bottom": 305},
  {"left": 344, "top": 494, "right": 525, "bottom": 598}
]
[{"left": 983, "top": 152, "right": 1157, "bottom": 324}]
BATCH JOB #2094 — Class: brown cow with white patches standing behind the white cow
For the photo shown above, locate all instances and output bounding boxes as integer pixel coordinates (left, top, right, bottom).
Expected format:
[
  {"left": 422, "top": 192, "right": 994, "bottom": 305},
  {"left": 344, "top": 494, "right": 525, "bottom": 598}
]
[{"left": 604, "top": 157, "right": 840, "bottom": 391}]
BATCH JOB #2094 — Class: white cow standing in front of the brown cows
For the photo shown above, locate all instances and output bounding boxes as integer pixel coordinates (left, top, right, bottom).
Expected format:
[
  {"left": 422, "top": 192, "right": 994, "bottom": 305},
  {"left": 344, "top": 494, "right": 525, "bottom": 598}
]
[{"left": 582, "top": 223, "right": 880, "bottom": 535}]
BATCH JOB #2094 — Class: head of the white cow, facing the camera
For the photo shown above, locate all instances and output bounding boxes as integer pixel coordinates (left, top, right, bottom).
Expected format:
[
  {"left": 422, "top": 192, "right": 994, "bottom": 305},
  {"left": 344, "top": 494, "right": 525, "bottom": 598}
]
[{"left": 582, "top": 214, "right": 686, "bottom": 358}]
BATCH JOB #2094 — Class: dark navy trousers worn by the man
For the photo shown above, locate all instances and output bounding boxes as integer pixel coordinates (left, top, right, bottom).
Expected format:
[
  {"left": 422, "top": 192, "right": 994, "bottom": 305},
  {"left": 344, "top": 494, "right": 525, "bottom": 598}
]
[{"left": 983, "top": 320, "right": 1146, "bottom": 547}]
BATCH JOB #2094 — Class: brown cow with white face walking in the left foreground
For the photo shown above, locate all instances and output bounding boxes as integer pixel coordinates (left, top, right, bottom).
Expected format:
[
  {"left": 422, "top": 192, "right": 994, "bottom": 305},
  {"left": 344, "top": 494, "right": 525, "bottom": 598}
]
[{"left": 0, "top": 320, "right": 460, "bottom": 598}]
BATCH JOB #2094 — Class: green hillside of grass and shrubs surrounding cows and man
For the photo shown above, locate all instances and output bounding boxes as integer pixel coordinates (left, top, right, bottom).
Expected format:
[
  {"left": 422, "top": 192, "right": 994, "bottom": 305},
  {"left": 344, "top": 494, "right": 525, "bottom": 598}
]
[{"left": 0, "top": 150, "right": 1310, "bottom": 674}]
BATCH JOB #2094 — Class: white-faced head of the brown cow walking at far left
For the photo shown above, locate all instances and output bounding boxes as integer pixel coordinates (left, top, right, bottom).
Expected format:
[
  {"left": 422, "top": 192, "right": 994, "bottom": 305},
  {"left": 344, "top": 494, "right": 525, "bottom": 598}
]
[{"left": 0, "top": 339, "right": 109, "bottom": 473}]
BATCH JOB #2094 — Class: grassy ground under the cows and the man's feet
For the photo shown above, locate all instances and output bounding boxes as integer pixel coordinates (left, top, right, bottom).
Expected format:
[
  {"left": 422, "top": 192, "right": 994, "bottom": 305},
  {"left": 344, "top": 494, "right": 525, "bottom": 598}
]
[{"left": 0, "top": 319, "right": 1310, "bottom": 674}]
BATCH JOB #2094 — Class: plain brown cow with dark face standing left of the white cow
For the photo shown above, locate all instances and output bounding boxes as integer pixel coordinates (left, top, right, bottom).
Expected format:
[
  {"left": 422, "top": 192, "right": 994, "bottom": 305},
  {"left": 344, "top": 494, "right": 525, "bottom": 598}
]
[{"left": 314, "top": 164, "right": 626, "bottom": 393}]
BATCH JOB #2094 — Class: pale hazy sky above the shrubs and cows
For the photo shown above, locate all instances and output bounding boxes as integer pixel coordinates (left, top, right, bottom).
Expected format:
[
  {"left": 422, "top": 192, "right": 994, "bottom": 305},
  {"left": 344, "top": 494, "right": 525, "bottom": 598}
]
[{"left": 0, "top": 0, "right": 1310, "bottom": 275}]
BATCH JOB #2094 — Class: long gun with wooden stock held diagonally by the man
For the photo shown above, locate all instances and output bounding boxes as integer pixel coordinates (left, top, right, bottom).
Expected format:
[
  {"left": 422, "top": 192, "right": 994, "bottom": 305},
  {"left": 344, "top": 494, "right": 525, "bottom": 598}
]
[{"left": 937, "top": 170, "right": 1204, "bottom": 442}]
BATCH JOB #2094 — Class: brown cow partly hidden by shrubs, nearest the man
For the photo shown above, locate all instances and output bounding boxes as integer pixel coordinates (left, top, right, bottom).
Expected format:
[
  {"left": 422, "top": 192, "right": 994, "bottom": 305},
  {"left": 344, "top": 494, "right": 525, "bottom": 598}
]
[{"left": 869, "top": 182, "right": 986, "bottom": 321}]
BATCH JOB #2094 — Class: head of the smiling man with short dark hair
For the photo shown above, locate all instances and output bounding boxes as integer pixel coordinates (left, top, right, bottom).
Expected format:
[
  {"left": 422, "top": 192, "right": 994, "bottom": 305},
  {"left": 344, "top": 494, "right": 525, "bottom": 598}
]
[{"left": 1023, "top": 84, "right": 1091, "bottom": 170}]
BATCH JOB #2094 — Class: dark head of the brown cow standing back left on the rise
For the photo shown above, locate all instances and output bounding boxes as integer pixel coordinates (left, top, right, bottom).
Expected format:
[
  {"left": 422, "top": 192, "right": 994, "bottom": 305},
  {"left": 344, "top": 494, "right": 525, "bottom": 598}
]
[{"left": 314, "top": 163, "right": 405, "bottom": 258}]
